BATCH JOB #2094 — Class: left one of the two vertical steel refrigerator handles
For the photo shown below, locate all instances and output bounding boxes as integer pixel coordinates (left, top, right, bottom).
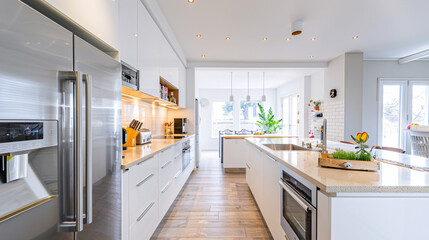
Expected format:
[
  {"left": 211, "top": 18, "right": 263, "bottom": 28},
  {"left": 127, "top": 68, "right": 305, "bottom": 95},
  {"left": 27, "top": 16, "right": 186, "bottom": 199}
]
[{"left": 58, "top": 71, "right": 83, "bottom": 232}]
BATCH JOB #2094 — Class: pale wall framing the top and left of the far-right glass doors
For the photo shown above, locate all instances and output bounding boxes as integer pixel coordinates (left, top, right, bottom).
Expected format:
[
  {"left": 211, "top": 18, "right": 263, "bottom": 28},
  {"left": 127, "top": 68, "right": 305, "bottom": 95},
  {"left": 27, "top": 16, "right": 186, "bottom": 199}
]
[{"left": 362, "top": 60, "right": 429, "bottom": 145}]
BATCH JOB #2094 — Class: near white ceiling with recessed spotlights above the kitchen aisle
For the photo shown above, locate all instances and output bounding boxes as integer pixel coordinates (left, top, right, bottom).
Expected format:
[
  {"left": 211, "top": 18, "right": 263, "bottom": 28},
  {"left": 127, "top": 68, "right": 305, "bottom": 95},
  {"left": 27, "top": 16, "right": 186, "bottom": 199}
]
[{"left": 157, "top": 0, "right": 429, "bottom": 62}]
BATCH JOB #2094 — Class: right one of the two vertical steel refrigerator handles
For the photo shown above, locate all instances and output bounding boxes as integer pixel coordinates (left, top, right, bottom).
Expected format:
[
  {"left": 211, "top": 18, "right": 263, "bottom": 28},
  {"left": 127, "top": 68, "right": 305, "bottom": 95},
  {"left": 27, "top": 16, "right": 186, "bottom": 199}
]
[{"left": 83, "top": 74, "right": 92, "bottom": 224}]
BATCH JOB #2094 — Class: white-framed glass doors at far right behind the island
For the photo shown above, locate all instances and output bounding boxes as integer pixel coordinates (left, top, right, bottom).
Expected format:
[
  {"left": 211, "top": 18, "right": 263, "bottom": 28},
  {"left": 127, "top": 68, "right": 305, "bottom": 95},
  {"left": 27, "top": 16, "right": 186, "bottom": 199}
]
[{"left": 378, "top": 79, "right": 429, "bottom": 148}]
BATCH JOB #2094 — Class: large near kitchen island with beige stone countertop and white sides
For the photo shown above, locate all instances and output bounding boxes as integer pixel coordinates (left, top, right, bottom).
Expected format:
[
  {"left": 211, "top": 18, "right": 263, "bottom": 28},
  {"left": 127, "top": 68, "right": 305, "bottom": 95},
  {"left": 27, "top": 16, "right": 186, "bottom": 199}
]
[{"left": 241, "top": 138, "right": 429, "bottom": 240}]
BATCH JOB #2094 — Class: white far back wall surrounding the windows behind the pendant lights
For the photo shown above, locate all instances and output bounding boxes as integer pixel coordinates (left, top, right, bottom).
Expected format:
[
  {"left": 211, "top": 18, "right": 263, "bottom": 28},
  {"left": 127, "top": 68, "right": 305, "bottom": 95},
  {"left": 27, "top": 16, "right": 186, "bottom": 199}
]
[{"left": 199, "top": 88, "right": 280, "bottom": 150}]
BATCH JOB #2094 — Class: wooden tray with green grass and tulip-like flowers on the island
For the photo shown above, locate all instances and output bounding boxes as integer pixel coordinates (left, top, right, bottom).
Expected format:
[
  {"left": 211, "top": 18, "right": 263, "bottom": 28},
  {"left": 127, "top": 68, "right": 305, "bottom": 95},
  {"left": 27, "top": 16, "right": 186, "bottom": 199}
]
[{"left": 319, "top": 132, "right": 380, "bottom": 171}]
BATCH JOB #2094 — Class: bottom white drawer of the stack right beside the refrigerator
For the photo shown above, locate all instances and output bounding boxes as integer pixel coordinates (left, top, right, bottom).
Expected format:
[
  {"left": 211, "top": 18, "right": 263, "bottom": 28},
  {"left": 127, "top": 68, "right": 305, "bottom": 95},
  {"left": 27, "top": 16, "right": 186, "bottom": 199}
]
[{"left": 130, "top": 202, "right": 159, "bottom": 240}]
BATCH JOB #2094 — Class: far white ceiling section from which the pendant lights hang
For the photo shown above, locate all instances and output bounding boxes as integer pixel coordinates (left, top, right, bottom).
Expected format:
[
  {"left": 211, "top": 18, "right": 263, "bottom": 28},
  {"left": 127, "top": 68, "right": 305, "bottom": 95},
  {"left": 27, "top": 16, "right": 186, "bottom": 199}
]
[{"left": 195, "top": 69, "right": 323, "bottom": 89}]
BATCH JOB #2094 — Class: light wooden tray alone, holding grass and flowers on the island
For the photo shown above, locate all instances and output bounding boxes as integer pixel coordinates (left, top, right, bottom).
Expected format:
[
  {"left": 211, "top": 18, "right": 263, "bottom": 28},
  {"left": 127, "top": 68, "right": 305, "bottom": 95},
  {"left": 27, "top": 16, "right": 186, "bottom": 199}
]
[{"left": 319, "top": 154, "right": 380, "bottom": 171}]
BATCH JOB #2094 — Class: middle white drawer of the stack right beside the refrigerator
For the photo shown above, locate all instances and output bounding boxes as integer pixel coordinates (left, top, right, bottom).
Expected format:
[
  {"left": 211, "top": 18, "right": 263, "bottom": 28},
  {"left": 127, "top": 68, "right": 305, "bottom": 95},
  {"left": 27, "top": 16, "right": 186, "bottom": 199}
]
[{"left": 129, "top": 173, "right": 158, "bottom": 223}]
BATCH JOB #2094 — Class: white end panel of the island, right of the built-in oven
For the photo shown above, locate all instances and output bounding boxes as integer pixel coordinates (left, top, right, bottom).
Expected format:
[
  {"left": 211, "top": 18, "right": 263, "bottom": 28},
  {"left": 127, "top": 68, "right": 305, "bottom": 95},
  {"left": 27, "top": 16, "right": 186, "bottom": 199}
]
[{"left": 317, "top": 191, "right": 429, "bottom": 240}]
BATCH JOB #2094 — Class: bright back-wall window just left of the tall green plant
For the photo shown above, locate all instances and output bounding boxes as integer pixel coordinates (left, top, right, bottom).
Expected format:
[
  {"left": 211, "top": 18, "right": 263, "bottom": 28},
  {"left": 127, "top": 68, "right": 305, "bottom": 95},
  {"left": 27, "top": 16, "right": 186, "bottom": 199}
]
[{"left": 239, "top": 101, "right": 264, "bottom": 131}]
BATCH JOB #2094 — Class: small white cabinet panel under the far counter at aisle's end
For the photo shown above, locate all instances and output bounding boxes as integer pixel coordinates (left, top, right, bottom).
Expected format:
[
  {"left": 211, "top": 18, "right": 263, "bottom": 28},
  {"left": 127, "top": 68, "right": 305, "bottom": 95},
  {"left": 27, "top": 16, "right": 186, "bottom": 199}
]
[{"left": 223, "top": 138, "right": 249, "bottom": 168}]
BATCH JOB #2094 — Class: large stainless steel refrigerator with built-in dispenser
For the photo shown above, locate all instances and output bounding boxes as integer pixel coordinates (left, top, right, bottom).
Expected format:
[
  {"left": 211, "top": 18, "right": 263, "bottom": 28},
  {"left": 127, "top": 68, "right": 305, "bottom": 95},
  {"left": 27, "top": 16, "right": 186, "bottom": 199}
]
[{"left": 0, "top": 0, "right": 122, "bottom": 240}]
